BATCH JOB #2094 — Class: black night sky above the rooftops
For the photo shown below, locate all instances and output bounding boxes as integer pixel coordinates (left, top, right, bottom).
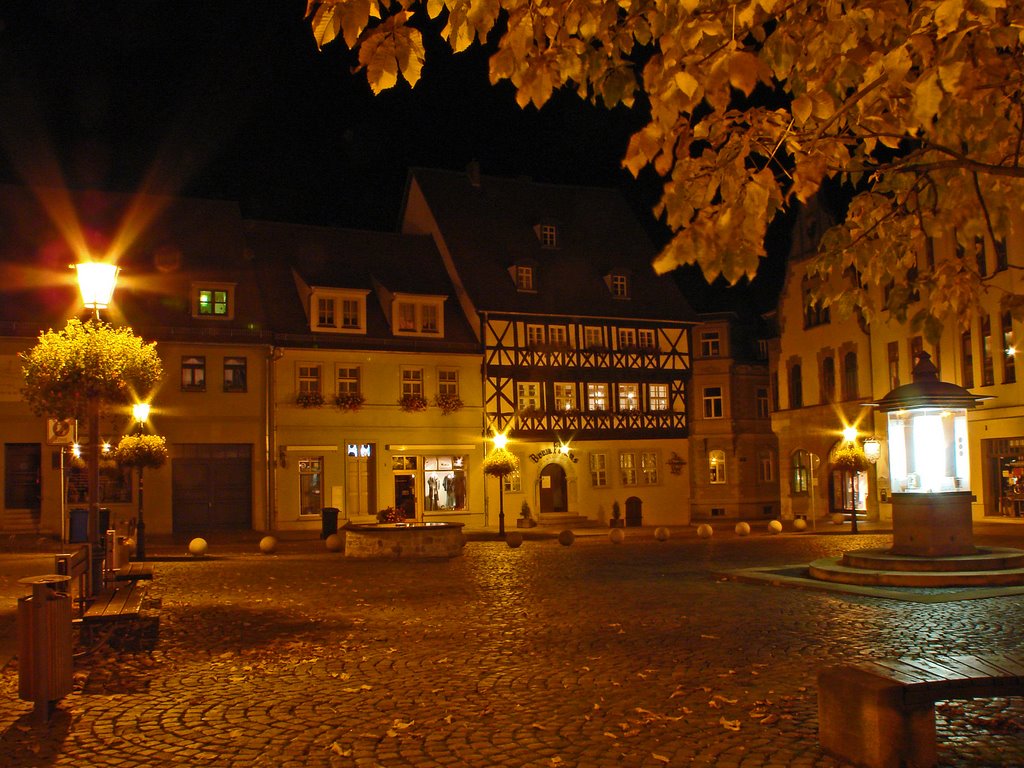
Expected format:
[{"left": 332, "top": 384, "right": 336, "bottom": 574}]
[{"left": 0, "top": 0, "right": 784, "bottom": 309}]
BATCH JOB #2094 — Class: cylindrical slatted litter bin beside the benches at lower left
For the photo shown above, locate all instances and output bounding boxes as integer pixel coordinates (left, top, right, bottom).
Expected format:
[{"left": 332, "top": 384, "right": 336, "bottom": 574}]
[{"left": 17, "top": 573, "right": 73, "bottom": 723}]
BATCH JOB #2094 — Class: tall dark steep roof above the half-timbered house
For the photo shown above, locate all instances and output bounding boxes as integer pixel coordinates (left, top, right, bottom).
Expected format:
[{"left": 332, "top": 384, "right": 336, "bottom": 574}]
[{"left": 402, "top": 168, "right": 694, "bottom": 322}]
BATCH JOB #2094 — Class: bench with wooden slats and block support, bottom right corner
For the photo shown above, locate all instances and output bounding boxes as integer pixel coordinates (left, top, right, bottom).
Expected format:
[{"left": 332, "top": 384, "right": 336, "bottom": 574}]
[{"left": 818, "top": 654, "right": 1024, "bottom": 768}]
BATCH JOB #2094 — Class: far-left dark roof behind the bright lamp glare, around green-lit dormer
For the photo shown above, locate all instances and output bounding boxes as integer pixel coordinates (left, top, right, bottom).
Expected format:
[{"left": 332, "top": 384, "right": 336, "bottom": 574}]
[{"left": 0, "top": 184, "right": 265, "bottom": 339}]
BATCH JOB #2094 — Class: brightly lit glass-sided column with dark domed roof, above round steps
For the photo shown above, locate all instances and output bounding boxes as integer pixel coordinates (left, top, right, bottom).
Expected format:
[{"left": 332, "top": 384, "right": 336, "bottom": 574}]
[{"left": 871, "top": 352, "right": 988, "bottom": 557}]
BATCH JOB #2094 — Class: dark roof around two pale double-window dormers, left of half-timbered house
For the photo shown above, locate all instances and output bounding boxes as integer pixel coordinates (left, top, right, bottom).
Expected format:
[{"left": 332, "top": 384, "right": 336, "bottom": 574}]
[{"left": 245, "top": 221, "right": 476, "bottom": 351}]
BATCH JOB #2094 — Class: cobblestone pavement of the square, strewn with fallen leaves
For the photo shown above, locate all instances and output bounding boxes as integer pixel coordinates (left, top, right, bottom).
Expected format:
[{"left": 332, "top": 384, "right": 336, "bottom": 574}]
[{"left": 0, "top": 527, "right": 1024, "bottom": 768}]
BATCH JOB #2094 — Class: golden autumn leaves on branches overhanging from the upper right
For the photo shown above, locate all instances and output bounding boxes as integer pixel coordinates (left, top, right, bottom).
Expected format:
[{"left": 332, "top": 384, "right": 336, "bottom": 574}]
[{"left": 307, "top": 0, "right": 1024, "bottom": 336}]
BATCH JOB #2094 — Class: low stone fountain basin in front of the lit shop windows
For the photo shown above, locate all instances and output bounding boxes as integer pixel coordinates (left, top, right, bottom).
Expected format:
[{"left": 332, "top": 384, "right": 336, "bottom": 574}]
[{"left": 342, "top": 522, "right": 466, "bottom": 559}]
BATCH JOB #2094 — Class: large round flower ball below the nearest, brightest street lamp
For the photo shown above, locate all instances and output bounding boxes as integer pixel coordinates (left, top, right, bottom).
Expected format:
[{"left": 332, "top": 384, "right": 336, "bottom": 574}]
[{"left": 22, "top": 319, "right": 164, "bottom": 419}]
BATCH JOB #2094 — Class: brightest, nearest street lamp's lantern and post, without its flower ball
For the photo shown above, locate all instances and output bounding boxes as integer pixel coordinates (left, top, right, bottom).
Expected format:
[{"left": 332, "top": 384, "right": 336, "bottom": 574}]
[{"left": 72, "top": 261, "right": 120, "bottom": 594}]
